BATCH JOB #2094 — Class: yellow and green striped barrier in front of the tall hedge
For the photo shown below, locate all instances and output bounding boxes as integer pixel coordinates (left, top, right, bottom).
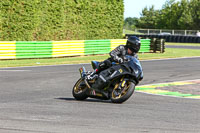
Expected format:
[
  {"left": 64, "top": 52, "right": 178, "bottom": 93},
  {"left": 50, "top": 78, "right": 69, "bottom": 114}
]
[{"left": 0, "top": 39, "right": 151, "bottom": 59}]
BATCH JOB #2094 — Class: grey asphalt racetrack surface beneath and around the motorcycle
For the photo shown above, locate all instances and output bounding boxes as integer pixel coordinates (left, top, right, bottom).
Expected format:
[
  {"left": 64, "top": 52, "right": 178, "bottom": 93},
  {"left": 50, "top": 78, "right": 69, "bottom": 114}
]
[{"left": 0, "top": 58, "right": 200, "bottom": 133}]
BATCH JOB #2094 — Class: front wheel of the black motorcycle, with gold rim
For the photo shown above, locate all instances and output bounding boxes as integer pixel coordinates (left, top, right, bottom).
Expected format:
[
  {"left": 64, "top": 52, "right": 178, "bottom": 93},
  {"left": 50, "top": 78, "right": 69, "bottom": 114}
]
[{"left": 111, "top": 81, "right": 135, "bottom": 103}]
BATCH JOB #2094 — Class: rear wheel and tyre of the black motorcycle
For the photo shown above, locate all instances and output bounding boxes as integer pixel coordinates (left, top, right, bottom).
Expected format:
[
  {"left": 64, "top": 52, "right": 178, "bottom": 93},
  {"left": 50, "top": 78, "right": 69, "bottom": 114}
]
[{"left": 72, "top": 78, "right": 88, "bottom": 100}]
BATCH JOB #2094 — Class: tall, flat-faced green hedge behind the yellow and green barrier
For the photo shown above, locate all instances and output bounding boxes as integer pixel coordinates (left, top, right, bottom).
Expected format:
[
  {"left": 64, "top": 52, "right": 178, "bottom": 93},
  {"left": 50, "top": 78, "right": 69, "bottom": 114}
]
[{"left": 0, "top": 0, "right": 124, "bottom": 41}]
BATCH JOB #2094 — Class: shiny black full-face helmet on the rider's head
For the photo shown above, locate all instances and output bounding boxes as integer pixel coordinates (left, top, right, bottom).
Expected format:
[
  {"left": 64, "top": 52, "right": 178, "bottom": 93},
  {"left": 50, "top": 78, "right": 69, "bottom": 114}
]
[{"left": 126, "top": 36, "right": 141, "bottom": 53}]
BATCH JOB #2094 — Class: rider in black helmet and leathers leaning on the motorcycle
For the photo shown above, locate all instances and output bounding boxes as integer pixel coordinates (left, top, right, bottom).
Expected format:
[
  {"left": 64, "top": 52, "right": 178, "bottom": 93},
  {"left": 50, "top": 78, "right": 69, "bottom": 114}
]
[{"left": 87, "top": 36, "right": 143, "bottom": 80}]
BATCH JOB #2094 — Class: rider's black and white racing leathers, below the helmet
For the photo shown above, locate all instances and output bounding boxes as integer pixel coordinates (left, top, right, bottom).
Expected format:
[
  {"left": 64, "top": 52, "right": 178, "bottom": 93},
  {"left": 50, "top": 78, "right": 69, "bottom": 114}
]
[{"left": 87, "top": 45, "right": 143, "bottom": 80}]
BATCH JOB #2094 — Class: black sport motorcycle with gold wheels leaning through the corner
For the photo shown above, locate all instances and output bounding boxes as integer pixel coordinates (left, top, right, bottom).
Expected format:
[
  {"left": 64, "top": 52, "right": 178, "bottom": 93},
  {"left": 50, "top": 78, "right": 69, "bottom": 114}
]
[{"left": 72, "top": 56, "right": 139, "bottom": 103}]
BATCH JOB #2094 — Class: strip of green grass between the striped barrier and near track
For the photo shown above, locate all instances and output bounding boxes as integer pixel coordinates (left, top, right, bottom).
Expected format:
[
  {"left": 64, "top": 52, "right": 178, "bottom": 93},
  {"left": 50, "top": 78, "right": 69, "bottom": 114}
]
[{"left": 0, "top": 48, "right": 200, "bottom": 67}]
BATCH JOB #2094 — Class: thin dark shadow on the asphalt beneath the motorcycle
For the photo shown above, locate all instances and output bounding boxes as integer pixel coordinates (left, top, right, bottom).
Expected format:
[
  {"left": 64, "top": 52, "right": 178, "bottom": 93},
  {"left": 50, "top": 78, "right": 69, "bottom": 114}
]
[{"left": 55, "top": 97, "right": 112, "bottom": 103}]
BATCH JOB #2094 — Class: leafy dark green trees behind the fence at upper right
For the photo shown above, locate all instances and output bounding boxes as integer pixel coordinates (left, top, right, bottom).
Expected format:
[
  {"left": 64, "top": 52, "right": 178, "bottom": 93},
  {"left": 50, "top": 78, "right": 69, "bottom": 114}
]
[{"left": 124, "top": 0, "right": 200, "bottom": 30}]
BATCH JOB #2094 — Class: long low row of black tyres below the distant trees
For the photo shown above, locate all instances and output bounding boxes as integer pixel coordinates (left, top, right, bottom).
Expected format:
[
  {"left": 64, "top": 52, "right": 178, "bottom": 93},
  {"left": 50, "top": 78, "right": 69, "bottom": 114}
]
[{"left": 126, "top": 34, "right": 200, "bottom": 43}]
